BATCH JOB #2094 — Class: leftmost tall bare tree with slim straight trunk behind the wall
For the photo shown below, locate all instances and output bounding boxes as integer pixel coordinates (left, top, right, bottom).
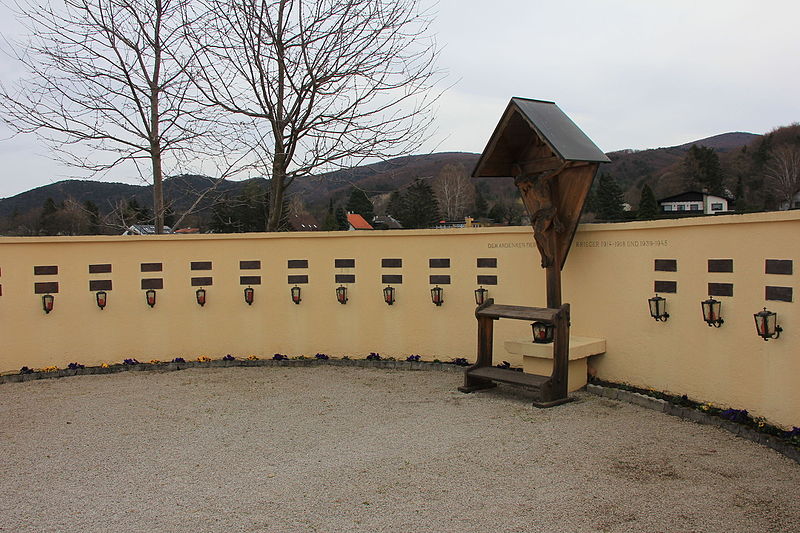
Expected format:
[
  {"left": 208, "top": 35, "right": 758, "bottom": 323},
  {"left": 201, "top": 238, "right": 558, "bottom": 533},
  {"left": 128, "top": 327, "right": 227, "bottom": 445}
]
[{"left": 0, "top": 0, "right": 225, "bottom": 233}]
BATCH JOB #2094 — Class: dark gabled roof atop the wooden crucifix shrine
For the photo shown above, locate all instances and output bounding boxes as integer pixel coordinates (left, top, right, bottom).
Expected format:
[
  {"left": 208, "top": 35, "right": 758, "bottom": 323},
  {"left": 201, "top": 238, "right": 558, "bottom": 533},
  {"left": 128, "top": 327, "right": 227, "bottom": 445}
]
[{"left": 472, "top": 97, "right": 611, "bottom": 178}]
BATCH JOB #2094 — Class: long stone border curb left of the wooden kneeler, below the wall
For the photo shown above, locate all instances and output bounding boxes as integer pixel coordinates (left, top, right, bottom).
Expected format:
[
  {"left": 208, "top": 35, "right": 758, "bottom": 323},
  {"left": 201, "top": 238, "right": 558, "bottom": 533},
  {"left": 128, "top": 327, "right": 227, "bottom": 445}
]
[{"left": 0, "top": 359, "right": 468, "bottom": 384}]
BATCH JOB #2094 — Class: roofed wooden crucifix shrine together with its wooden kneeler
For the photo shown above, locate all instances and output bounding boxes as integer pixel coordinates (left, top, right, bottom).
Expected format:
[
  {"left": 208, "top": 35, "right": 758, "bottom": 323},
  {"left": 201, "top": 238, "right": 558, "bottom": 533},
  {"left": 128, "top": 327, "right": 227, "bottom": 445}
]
[{"left": 459, "top": 98, "right": 610, "bottom": 407}]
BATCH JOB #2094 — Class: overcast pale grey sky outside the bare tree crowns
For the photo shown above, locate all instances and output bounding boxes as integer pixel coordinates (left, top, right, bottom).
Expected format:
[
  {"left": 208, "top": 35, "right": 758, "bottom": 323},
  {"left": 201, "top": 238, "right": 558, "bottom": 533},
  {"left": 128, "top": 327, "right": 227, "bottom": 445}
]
[{"left": 0, "top": 0, "right": 800, "bottom": 197}]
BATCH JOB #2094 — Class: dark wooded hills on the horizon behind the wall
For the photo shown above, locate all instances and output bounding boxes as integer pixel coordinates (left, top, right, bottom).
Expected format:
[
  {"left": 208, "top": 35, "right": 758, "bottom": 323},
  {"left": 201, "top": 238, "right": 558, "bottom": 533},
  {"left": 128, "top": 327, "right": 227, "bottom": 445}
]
[{"left": 0, "top": 127, "right": 795, "bottom": 233}]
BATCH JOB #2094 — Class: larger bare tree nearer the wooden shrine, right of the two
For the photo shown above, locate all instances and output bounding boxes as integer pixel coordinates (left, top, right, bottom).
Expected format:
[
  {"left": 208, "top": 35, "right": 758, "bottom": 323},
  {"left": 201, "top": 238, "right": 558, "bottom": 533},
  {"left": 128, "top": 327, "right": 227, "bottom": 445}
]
[{"left": 187, "top": 0, "right": 438, "bottom": 231}]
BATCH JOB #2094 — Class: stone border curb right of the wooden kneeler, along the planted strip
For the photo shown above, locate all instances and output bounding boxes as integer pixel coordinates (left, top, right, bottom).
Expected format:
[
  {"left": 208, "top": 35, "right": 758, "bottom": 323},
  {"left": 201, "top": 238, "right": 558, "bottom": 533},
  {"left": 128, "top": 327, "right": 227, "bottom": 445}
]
[{"left": 586, "top": 383, "right": 800, "bottom": 463}]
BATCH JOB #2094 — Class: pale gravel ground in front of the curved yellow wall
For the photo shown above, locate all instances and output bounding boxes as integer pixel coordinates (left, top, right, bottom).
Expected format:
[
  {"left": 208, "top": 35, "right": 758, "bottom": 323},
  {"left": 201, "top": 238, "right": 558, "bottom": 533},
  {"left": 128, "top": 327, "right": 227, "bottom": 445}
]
[{"left": 0, "top": 366, "right": 800, "bottom": 533}]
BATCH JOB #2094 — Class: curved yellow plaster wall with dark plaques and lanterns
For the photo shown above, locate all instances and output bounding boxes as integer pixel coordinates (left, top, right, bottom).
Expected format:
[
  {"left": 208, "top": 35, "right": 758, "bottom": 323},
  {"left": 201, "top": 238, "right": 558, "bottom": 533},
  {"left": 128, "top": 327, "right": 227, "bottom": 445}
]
[{"left": 0, "top": 212, "right": 800, "bottom": 425}]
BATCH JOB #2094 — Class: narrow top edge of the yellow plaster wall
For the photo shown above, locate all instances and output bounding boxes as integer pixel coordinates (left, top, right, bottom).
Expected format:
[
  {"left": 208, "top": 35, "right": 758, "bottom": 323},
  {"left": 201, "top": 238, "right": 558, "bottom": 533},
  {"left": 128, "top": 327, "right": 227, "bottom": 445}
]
[{"left": 0, "top": 210, "right": 800, "bottom": 245}]
